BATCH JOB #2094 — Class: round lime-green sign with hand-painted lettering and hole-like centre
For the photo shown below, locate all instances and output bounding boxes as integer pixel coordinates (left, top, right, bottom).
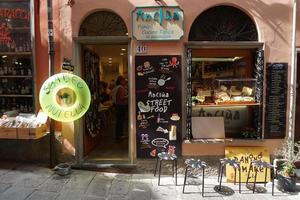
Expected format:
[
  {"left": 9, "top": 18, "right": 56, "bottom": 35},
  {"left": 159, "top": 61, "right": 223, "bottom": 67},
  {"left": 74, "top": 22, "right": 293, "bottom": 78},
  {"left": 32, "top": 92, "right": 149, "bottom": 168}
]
[{"left": 39, "top": 73, "right": 91, "bottom": 122}]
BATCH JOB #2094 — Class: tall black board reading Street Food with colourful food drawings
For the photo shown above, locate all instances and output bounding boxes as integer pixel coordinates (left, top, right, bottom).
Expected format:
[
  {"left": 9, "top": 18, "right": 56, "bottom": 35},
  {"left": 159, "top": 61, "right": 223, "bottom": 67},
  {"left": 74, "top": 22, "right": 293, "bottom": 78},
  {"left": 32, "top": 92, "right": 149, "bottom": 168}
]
[{"left": 135, "top": 55, "right": 182, "bottom": 158}]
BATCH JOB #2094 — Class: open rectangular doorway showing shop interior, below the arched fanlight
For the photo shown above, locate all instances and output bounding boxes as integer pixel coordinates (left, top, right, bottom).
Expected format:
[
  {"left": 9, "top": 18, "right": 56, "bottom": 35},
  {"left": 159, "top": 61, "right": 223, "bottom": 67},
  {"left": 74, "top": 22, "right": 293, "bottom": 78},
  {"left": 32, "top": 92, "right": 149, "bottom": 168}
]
[{"left": 82, "top": 44, "right": 129, "bottom": 162}]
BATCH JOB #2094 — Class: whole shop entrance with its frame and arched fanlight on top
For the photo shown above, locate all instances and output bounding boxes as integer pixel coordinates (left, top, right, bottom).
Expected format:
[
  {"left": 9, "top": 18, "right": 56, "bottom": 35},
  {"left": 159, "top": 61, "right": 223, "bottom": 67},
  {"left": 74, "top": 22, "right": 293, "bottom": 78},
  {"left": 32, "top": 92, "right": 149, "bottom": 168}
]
[{"left": 73, "top": 11, "right": 133, "bottom": 167}]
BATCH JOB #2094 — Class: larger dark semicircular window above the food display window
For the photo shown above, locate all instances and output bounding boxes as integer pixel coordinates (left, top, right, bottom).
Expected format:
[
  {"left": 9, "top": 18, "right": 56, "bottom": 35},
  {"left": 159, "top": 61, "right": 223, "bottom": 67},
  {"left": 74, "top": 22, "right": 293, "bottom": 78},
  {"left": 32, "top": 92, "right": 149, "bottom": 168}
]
[{"left": 189, "top": 6, "right": 258, "bottom": 41}]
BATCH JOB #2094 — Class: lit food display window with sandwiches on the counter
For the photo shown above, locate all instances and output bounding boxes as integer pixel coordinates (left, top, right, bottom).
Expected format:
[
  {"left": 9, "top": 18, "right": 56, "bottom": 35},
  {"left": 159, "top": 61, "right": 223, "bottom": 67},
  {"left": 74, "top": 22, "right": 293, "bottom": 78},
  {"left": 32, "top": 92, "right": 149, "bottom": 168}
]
[{"left": 190, "top": 49, "right": 259, "bottom": 139}]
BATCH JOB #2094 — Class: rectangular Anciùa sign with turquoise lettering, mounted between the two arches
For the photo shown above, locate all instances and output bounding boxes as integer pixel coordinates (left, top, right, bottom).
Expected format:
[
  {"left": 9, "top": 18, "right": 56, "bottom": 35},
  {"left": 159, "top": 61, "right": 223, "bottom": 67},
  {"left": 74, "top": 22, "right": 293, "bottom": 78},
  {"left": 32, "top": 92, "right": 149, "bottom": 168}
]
[{"left": 132, "top": 6, "right": 183, "bottom": 41}]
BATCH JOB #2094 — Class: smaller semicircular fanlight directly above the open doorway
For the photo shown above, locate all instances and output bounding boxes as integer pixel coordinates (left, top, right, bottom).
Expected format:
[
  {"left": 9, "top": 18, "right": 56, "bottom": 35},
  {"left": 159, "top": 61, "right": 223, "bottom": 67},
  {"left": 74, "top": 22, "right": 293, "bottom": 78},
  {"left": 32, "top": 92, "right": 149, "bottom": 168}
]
[{"left": 79, "top": 11, "right": 128, "bottom": 36}]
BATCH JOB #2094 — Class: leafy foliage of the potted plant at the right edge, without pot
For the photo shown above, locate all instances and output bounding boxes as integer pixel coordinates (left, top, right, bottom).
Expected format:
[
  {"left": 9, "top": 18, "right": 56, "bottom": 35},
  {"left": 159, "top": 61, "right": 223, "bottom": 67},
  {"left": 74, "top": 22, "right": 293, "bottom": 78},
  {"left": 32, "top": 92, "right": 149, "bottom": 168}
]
[{"left": 275, "top": 138, "right": 300, "bottom": 176}]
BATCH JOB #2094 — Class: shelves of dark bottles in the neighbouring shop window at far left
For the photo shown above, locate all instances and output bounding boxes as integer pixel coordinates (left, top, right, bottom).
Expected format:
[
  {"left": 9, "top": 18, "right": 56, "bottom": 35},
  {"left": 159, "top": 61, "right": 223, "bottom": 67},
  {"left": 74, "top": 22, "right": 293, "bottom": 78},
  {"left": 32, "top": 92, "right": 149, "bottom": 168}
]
[{"left": 0, "top": 0, "right": 34, "bottom": 114}]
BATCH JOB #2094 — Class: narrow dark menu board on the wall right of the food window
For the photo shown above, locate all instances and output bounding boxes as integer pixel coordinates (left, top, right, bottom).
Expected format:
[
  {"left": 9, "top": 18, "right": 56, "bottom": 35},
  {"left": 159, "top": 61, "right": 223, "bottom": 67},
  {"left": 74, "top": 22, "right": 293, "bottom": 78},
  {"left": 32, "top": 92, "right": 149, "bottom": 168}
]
[{"left": 265, "top": 63, "right": 288, "bottom": 138}]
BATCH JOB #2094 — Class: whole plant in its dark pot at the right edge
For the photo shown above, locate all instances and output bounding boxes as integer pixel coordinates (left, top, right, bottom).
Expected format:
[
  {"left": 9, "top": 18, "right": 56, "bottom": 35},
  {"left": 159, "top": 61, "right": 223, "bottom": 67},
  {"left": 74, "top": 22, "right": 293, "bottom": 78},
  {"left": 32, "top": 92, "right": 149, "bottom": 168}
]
[{"left": 274, "top": 138, "right": 300, "bottom": 192}]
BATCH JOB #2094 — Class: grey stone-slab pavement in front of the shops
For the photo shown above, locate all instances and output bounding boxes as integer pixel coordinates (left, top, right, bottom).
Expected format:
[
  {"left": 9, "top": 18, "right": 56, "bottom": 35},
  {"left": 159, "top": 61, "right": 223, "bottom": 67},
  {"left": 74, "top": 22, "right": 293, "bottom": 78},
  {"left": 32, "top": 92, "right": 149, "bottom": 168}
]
[{"left": 0, "top": 163, "right": 300, "bottom": 200}]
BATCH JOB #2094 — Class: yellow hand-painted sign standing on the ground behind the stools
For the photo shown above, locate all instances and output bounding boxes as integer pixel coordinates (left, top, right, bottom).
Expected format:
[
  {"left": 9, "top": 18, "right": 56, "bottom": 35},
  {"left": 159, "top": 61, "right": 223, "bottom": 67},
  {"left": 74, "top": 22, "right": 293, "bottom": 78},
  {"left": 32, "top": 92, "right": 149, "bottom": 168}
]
[{"left": 225, "top": 147, "right": 270, "bottom": 182}]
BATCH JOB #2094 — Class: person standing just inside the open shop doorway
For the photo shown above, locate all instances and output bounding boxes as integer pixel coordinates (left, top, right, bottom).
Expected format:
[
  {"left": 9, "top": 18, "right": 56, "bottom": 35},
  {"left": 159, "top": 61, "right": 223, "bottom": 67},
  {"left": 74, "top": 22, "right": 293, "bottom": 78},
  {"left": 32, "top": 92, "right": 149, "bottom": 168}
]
[{"left": 112, "top": 76, "right": 128, "bottom": 140}]
